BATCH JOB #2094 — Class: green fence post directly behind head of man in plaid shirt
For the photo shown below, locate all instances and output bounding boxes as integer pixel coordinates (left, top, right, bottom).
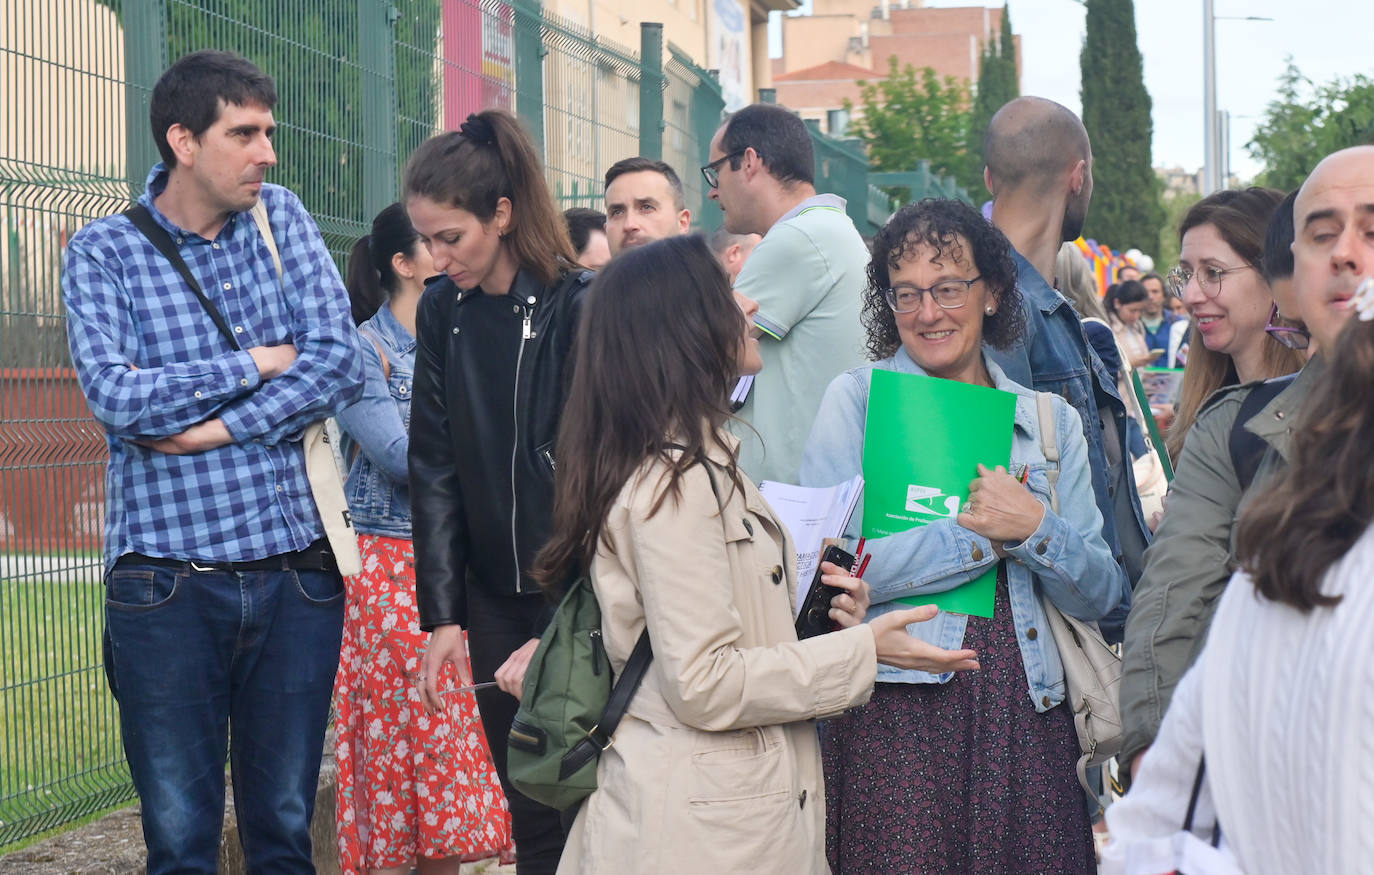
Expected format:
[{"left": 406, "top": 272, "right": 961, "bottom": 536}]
[{"left": 122, "top": 0, "right": 168, "bottom": 199}]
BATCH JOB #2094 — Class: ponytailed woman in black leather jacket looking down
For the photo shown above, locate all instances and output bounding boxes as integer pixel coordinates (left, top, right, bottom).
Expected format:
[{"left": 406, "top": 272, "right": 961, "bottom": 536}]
[{"left": 404, "top": 110, "right": 591, "bottom": 875}]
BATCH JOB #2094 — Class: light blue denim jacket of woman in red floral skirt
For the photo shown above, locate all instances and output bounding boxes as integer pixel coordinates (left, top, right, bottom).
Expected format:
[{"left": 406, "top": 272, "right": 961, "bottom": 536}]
[{"left": 338, "top": 304, "right": 415, "bottom": 537}]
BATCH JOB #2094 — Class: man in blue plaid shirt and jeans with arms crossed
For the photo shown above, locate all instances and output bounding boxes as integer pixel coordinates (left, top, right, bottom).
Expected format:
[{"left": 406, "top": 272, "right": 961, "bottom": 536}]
[{"left": 62, "top": 52, "right": 363, "bottom": 874}]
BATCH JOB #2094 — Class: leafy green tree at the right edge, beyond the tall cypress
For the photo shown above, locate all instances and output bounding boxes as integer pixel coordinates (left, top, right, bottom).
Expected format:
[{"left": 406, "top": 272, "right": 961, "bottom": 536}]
[{"left": 1245, "top": 58, "right": 1374, "bottom": 191}]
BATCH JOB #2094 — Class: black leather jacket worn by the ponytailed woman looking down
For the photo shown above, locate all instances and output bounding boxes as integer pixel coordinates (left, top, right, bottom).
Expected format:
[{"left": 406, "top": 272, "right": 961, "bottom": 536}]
[{"left": 409, "top": 262, "right": 592, "bottom": 633}]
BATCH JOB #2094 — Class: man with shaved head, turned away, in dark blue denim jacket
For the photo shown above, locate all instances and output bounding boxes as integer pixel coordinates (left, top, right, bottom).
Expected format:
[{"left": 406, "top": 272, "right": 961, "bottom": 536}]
[{"left": 982, "top": 98, "right": 1150, "bottom": 629}]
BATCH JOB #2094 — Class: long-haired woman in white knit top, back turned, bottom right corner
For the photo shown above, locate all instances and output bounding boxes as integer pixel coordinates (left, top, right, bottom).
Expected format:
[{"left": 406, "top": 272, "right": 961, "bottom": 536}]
[{"left": 1103, "top": 298, "right": 1374, "bottom": 875}]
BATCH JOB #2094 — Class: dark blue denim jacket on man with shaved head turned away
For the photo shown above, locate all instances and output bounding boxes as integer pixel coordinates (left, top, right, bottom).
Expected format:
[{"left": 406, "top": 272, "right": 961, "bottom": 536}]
[{"left": 988, "top": 249, "right": 1150, "bottom": 641}]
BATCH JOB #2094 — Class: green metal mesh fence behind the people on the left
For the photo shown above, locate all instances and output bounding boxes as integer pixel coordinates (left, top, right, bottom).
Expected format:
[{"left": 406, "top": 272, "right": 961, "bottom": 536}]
[{"left": 0, "top": 0, "right": 723, "bottom": 849}]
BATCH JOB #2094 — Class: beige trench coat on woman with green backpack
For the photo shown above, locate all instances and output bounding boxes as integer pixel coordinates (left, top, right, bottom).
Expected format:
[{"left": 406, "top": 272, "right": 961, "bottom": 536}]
[{"left": 558, "top": 437, "right": 877, "bottom": 875}]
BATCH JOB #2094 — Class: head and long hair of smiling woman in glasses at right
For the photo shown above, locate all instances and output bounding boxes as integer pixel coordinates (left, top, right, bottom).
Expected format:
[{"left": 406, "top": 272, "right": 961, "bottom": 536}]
[{"left": 1165, "top": 185, "right": 1304, "bottom": 460}]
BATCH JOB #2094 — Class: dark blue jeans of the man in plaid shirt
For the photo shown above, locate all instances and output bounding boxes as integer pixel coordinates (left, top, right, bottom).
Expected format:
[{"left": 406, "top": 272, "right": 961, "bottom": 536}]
[{"left": 104, "top": 562, "right": 344, "bottom": 875}]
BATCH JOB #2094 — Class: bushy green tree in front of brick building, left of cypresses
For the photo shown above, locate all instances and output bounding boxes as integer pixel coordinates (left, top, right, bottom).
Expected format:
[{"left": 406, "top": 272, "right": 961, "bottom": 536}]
[{"left": 845, "top": 56, "right": 969, "bottom": 184}]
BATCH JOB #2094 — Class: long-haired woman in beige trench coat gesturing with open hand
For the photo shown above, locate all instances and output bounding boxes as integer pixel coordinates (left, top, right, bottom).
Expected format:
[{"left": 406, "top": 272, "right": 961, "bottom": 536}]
[{"left": 537, "top": 236, "right": 977, "bottom": 875}]
